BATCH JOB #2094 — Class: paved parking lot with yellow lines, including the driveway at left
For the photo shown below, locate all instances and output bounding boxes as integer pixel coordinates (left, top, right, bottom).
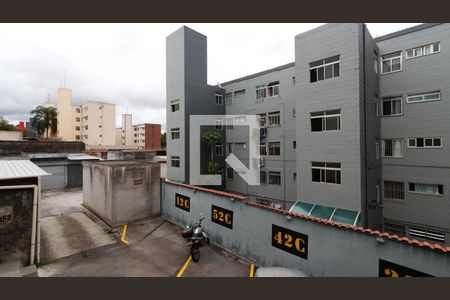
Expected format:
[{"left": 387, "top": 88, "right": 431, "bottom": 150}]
[{"left": 38, "top": 190, "right": 249, "bottom": 277}]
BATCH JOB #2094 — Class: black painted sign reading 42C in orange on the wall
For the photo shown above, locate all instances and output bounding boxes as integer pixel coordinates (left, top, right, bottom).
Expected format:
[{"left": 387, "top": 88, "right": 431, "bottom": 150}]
[{"left": 272, "top": 224, "right": 308, "bottom": 259}]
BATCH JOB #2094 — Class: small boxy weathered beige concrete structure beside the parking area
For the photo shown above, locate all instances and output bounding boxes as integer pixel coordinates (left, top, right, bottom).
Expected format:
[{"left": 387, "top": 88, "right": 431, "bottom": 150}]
[{"left": 83, "top": 161, "right": 160, "bottom": 227}]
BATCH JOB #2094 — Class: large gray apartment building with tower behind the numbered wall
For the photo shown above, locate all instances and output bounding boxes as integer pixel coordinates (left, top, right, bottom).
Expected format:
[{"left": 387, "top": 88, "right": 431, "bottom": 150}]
[{"left": 166, "top": 23, "right": 450, "bottom": 245}]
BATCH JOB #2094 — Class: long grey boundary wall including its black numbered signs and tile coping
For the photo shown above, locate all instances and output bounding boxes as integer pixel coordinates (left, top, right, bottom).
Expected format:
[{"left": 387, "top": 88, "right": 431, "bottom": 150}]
[{"left": 161, "top": 181, "right": 450, "bottom": 277}]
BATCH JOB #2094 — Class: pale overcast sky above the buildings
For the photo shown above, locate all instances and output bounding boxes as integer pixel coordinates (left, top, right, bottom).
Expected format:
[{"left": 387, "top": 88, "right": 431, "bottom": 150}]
[{"left": 0, "top": 23, "right": 418, "bottom": 129}]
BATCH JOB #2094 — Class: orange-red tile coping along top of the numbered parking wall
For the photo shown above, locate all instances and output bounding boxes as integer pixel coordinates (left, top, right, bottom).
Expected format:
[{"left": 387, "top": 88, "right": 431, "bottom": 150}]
[{"left": 163, "top": 179, "right": 450, "bottom": 253}]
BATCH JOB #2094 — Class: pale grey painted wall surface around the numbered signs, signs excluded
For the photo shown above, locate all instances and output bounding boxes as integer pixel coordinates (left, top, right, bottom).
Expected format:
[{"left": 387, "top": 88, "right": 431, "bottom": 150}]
[{"left": 161, "top": 182, "right": 450, "bottom": 277}]
